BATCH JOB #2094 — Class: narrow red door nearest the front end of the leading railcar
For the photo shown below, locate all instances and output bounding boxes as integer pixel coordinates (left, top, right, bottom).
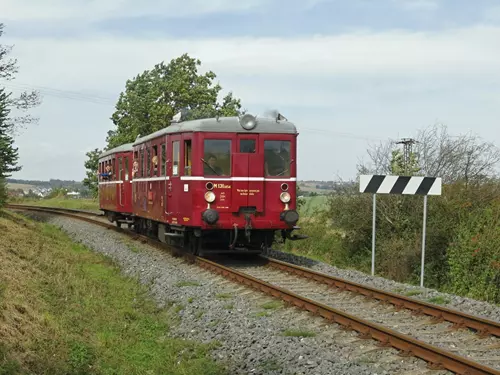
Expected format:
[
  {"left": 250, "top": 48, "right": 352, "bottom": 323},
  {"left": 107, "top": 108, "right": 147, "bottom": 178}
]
[{"left": 167, "top": 135, "right": 182, "bottom": 224}]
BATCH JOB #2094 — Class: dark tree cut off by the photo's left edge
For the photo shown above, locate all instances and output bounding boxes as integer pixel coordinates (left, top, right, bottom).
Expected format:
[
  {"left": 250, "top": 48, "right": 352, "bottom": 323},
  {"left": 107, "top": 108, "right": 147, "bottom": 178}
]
[{"left": 0, "top": 23, "right": 40, "bottom": 207}]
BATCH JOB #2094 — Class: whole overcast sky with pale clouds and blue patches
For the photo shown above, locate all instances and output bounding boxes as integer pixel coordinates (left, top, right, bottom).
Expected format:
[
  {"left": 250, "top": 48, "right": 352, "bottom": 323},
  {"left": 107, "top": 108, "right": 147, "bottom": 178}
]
[{"left": 0, "top": 0, "right": 500, "bottom": 180}]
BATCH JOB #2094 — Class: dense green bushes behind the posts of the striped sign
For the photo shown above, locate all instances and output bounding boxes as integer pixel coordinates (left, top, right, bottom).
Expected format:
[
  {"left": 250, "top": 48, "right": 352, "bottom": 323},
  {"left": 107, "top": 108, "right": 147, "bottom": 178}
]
[{"left": 328, "top": 179, "right": 500, "bottom": 302}]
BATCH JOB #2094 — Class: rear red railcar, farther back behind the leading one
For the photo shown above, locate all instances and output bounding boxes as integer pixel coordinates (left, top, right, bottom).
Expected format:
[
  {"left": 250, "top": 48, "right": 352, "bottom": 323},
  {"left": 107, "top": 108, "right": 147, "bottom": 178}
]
[{"left": 98, "top": 143, "right": 133, "bottom": 227}]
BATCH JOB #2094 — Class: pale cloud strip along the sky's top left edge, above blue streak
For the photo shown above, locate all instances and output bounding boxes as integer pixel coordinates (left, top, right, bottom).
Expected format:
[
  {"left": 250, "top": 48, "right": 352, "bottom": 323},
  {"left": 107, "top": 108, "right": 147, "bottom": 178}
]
[{"left": 0, "top": 0, "right": 263, "bottom": 22}]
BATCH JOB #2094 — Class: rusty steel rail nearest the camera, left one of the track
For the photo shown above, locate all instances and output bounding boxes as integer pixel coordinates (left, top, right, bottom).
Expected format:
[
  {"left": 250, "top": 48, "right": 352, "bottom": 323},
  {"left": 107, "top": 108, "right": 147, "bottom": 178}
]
[{"left": 8, "top": 205, "right": 500, "bottom": 375}]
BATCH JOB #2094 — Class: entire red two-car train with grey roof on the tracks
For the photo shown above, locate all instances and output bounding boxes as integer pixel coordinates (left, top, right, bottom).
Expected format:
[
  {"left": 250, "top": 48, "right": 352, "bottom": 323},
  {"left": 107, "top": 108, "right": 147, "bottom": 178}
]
[{"left": 98, "top": 114, "right": 307, "bottom": 255}]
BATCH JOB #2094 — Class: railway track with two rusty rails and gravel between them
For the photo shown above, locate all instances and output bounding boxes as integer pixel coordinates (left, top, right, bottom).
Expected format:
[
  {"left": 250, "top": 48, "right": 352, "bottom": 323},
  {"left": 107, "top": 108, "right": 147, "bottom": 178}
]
[{"left": 8, "top": 205, "right": 500, "bottom": 375}]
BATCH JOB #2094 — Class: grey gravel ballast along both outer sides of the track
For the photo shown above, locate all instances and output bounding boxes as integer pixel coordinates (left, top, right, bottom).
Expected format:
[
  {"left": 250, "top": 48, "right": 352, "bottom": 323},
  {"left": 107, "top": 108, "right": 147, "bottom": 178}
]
[{"left": 19, "top": 213, "right": 500, "bottom": 375}]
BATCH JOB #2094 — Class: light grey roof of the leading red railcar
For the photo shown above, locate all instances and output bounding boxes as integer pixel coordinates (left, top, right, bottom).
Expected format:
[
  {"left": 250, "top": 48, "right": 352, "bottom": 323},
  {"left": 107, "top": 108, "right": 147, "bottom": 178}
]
[{"left": 133, "top": 117, "right": 297, "bottom": 146}]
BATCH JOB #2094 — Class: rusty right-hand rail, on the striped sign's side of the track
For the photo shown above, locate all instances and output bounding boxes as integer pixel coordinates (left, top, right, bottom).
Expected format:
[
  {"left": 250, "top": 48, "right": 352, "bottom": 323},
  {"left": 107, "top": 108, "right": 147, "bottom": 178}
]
[{"left": 263, "top": 257, "right": 500, "bottom": 337}]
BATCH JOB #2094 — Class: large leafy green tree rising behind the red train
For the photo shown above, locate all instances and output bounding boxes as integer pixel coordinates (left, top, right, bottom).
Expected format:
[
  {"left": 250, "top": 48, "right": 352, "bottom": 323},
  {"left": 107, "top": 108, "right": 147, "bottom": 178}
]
[{"left": 106, "top": 54, "right": 241, "bottom": 149}]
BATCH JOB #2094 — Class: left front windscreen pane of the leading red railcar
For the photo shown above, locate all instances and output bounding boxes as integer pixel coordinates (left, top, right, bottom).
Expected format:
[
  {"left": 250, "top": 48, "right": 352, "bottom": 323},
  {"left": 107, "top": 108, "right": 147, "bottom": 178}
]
[{"left": 203, "top": 139, "right": 231, "bottom": 176}]
